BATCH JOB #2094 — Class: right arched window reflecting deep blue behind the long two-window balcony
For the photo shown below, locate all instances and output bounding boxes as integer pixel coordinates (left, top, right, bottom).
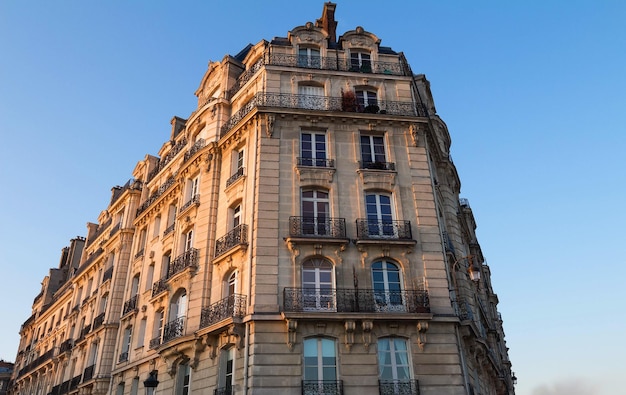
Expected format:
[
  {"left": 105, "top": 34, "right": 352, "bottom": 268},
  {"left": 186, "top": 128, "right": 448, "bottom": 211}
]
[{"left": 372, "top": 260, "right": 405, "bottom": 311}]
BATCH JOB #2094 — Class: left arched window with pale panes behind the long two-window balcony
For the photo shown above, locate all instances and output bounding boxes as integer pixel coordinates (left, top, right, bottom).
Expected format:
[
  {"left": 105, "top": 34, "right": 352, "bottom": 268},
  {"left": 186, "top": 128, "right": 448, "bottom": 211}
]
[{"left": 302, "top": 258, "right": 336, "bottom": 311}]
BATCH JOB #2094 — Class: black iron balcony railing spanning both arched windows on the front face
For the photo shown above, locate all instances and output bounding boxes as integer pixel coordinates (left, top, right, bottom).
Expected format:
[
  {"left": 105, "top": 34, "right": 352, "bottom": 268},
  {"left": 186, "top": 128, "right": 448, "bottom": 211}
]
[{"left": 283, "top": 288, "right": 430, "bottom": 314}]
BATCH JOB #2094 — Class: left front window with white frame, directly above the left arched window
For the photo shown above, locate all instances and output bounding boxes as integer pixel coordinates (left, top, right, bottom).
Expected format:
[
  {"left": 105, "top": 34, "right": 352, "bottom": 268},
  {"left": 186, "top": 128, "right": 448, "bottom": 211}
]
[{"left": 301, "top": 189, "right": 330, "bottom": 236}]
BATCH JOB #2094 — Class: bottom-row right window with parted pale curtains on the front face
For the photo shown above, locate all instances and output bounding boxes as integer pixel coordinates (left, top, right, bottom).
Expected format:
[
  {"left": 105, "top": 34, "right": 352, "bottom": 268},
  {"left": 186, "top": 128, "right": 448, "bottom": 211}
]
[{"left": 378, "top": 337, "right": 414, "bottom": 394}]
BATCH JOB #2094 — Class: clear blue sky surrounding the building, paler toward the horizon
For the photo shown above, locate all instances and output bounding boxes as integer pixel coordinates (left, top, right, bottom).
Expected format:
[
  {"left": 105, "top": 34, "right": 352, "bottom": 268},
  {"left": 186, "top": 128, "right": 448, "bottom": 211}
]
[{"left": 0, "top": 0, "right": 626, "bottom": 395}]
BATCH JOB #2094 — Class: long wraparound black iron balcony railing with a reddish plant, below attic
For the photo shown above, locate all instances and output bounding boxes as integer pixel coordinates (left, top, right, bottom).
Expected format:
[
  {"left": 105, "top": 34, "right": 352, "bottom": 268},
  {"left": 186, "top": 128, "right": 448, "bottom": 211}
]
[{"left": 220, "top": 92, "right": 427, "bottom": 137}]
